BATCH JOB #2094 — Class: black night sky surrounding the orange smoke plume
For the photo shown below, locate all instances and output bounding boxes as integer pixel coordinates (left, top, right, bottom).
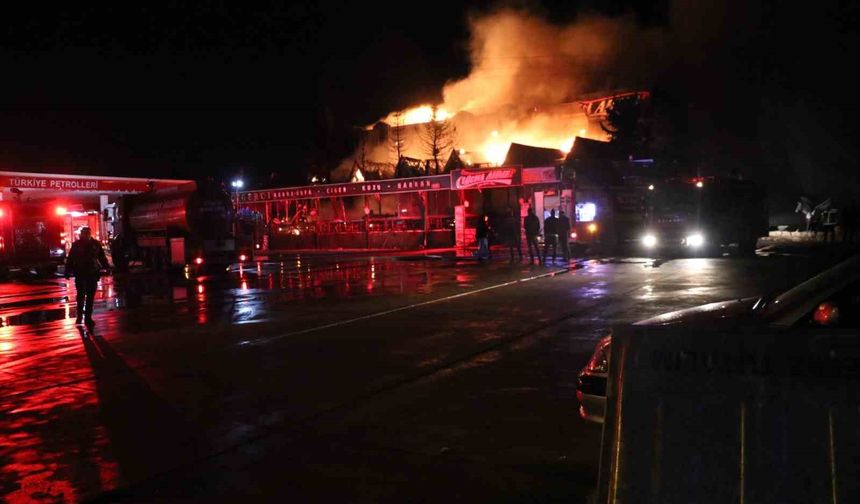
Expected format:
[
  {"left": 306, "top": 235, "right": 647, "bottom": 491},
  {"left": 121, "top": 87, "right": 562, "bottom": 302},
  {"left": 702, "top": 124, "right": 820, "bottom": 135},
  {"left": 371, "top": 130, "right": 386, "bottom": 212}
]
[{"left": 0, "top": 0, "right": 860, "bottom": 200}]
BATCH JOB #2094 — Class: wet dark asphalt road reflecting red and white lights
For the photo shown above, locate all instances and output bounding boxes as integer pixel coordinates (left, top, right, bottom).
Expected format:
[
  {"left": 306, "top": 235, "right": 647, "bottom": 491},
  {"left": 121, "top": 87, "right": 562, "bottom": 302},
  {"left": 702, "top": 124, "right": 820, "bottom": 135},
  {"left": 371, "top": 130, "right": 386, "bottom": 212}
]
[{"left": 0, "top": 250, "right": 840, "bottom": 502}]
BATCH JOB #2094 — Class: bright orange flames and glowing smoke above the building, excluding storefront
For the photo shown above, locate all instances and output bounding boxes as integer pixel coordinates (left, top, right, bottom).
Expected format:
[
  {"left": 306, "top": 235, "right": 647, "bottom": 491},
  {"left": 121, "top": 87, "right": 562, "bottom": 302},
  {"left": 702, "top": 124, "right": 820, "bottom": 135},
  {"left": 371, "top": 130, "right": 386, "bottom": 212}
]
[{"left": 334, "top": 10, "right": 643, "bottom": 179}]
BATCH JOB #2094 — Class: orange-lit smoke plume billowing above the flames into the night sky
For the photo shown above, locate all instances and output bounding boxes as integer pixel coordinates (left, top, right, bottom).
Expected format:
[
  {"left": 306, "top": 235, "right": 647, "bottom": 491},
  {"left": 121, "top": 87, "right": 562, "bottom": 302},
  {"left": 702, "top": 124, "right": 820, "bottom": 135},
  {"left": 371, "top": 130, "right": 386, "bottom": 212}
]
[{"left": 443, "top": 10, "right": 659, "bottom": 114}]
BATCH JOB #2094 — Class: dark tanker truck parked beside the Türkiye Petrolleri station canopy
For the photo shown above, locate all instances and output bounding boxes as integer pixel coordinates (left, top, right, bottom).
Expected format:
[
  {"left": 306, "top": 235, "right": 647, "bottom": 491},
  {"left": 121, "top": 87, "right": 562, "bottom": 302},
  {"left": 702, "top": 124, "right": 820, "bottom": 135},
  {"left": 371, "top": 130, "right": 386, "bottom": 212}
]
[{"left": 109, "top": 183, "right": 244, "bottom": 273}]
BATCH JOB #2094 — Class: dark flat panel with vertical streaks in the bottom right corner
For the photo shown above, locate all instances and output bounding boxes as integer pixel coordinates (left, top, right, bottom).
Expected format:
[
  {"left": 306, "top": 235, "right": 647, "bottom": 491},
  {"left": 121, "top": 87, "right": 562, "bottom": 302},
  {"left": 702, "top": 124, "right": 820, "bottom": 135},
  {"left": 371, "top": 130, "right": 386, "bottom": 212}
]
[{"left": 598, "top": 327, "right": 860, "bottom": 504}]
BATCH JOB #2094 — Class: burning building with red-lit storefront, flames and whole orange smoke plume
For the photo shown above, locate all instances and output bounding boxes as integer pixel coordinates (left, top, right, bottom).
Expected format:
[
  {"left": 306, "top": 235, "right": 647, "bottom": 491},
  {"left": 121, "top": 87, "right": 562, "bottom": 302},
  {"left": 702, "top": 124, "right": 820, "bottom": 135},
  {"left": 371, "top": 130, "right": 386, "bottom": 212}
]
[{"left": 235, "top": 10, "right": 660, "bottom": 254}]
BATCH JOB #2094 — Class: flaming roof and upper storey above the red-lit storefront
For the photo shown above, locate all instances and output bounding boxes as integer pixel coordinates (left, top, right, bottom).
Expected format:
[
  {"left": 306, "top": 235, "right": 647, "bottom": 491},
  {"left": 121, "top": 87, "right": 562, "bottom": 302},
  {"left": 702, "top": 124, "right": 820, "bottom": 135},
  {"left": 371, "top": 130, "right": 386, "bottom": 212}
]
[{"left": 332, "top": 90, "right": 649, "bottom": 182}]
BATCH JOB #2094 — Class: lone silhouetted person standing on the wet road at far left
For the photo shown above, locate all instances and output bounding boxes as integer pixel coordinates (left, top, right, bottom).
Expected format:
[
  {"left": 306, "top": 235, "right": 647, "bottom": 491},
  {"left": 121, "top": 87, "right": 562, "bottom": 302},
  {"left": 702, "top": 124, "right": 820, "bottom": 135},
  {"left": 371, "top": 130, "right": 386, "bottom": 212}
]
[{"left": 65, "top": 227, "right": 110, "bottom": 325}]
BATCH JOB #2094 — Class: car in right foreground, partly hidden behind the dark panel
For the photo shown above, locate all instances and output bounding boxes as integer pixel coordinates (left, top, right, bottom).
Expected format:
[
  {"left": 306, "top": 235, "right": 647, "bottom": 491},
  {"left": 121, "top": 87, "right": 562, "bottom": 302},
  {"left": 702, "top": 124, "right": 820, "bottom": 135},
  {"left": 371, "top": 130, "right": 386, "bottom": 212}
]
[{"left": 576, "top": 255, "right": 860, "bottom": 423}]
